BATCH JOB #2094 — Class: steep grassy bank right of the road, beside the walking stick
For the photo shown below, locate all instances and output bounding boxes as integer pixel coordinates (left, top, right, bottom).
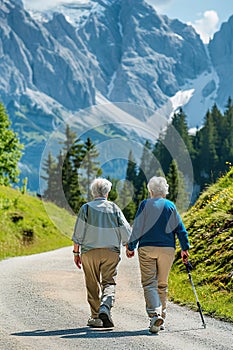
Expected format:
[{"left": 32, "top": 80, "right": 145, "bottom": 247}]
[{"left": 169, "top": 168, "right": 233, "bottom": 321}]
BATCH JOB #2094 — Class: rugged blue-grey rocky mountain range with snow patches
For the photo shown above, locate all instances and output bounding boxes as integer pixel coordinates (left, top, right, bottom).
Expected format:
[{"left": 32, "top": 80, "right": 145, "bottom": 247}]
[{"left": 0, "top": 0, "right": 233, "bottom": 190}]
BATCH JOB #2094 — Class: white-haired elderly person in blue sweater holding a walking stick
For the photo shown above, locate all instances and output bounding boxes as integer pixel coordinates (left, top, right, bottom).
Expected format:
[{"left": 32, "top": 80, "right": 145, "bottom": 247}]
[{"left": 126, "top": 176, "right": 189, "bottom": 333}]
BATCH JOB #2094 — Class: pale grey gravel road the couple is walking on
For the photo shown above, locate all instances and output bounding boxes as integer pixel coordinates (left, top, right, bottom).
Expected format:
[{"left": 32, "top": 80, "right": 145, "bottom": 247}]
[{"left": 0, "top": 247, "right": 233, "bottom": 350}]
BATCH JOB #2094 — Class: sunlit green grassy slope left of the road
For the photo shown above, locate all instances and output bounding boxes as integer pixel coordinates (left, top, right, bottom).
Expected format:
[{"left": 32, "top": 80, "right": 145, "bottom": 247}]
[{"left": 0, "top": 186, "right": 75, "bottom": 259}]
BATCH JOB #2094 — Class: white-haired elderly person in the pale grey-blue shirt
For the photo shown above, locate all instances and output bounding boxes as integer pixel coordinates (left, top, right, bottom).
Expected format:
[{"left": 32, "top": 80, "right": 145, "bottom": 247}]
[{"left": 72, "top": 178, "right": 131, "bottom": 327}]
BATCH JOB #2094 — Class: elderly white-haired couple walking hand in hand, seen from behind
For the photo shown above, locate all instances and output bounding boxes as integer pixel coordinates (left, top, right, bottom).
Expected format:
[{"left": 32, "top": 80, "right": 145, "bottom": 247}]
[{"left": 72, "top": 176, "right": 189, "bottom": 333}]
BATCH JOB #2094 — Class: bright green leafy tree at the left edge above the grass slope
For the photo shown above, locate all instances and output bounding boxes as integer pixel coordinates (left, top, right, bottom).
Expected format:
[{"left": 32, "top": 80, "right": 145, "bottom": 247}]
[{"left": 0, "top": 103, "right": 23, "bottom": 186}]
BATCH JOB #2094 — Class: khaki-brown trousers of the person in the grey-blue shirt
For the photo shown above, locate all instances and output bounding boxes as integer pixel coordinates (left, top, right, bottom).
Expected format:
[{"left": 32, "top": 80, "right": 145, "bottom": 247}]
[{"left": 82, "top": 248, "right": 120, "bottom": 318}]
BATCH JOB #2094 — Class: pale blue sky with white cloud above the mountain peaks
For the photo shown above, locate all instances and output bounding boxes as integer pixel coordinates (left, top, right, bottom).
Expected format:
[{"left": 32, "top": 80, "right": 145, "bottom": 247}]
[{"left": 23, "top": 0, "right": 233, "bottom": 42}]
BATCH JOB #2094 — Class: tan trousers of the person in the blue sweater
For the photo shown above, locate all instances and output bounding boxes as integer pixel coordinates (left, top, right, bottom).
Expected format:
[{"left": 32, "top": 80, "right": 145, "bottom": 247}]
[{"left": 138, "top": 246, "right": 175, "bottom": 318}]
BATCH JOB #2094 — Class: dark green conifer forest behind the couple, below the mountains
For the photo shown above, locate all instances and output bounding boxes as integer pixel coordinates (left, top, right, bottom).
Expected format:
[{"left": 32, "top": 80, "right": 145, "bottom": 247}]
[{"left": 43, "top": 98, "right": 233, "bottom": 222}]
